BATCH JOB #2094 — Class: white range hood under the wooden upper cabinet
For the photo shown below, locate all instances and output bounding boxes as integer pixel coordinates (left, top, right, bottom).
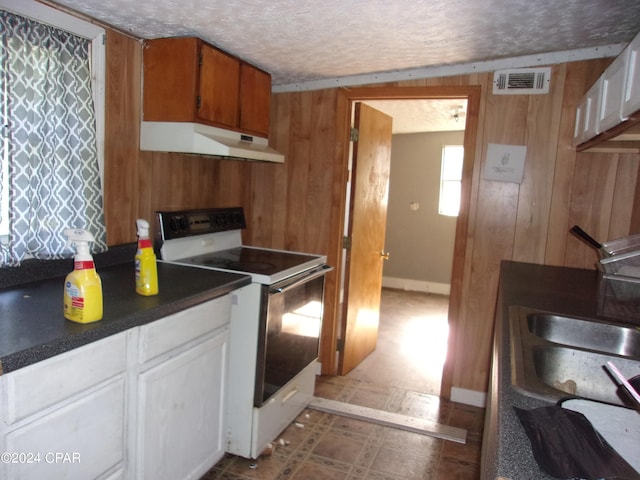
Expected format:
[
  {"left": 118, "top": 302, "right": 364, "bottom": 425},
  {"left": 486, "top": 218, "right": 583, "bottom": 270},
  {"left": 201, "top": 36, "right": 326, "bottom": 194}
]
[{"left": 140, "top": 122, "right": 284, "bottom": 163}]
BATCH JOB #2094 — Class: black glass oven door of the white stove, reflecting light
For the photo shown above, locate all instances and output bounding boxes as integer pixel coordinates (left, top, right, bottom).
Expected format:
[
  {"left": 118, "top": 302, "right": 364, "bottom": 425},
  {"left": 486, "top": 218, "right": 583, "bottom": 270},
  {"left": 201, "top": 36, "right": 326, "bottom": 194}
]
[{"left": 254, "top": 265, "right": 331, "bottom": 407}]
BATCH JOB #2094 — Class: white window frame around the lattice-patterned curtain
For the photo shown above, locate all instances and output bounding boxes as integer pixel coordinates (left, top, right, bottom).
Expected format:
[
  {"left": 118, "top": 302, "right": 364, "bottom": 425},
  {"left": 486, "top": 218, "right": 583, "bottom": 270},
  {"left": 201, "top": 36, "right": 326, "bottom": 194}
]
[{"left": 0, "top": 0, "right": 106, "bottom": 241}]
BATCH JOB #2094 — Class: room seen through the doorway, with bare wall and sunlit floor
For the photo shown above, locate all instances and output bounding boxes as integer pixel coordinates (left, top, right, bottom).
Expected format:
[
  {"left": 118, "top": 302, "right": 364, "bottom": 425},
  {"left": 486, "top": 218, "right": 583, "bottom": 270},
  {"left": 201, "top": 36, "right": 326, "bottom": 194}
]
[{"left": 347, "top": 99, "right": 466, "bottom": 395}]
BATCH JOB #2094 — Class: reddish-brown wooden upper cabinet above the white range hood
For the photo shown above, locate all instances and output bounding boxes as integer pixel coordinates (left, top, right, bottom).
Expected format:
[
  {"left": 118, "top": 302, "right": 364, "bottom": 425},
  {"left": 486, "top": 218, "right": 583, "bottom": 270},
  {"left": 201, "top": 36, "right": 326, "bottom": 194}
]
[{"left": 143, "top": 37, "right": 271, "bottom": 137}]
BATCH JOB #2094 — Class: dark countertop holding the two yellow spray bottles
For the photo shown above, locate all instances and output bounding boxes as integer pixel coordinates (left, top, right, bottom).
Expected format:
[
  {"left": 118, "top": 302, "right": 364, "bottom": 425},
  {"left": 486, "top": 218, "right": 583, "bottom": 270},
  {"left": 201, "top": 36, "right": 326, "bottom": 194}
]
[{"left": 0, "top": 256, "right": 250, "bottom": 373}]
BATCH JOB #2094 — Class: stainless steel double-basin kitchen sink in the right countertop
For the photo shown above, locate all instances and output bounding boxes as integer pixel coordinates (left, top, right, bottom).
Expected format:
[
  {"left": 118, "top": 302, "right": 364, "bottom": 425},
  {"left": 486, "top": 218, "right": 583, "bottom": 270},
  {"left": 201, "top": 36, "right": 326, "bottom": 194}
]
[{"left": 510, "top": 306, "right": 640, "bottom": 406}]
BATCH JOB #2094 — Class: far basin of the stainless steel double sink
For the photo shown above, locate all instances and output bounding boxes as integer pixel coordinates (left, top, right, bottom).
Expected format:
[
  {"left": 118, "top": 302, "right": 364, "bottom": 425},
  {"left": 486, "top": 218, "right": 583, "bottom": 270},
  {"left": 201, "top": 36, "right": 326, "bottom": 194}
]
[{"left": 527, "top": 313, "right": 640, "bottom": 358}]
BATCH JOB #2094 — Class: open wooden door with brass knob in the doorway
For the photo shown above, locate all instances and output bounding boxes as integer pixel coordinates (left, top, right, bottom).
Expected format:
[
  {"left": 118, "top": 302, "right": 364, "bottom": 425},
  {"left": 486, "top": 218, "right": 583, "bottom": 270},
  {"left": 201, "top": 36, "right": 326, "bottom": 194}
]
[{"left": 339, "top": 103, "right": 392, "bottom": 375}]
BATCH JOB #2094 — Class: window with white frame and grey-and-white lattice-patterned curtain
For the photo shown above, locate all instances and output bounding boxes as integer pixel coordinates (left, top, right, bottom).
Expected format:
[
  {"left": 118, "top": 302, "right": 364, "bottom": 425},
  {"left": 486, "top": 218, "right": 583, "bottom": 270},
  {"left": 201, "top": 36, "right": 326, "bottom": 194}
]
[{"left": 0, "top": 0, "right": 106, "bottom": 265}]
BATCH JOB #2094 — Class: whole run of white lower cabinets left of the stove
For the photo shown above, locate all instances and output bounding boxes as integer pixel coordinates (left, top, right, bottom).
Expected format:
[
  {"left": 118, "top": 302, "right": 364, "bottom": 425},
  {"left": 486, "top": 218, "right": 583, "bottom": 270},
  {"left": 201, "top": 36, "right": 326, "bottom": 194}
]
[{"left": 0, "top": 295, "right": 231, "bottom": 480}]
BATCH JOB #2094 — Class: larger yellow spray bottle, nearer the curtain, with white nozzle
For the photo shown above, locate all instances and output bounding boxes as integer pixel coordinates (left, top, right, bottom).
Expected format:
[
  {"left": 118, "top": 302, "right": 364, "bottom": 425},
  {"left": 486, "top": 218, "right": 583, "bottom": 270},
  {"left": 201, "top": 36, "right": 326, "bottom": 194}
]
[{"left": 64, "top": 228, "right": 102, "bottom": 323}]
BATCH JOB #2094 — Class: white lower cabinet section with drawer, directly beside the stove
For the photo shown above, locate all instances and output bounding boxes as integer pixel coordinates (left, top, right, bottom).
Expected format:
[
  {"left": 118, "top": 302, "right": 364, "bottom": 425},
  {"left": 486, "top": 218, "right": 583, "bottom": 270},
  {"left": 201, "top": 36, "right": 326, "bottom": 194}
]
[{"left": 131, "top": 296, "right": 231, "bottom": 480}]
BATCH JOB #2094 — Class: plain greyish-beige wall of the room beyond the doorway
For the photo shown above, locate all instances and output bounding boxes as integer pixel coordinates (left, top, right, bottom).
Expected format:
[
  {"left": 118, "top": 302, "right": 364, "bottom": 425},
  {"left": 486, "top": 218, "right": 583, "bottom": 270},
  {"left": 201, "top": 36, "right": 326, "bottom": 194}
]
[{"left": 383, "top": 131, "right": 464, "bottom": 294}]
